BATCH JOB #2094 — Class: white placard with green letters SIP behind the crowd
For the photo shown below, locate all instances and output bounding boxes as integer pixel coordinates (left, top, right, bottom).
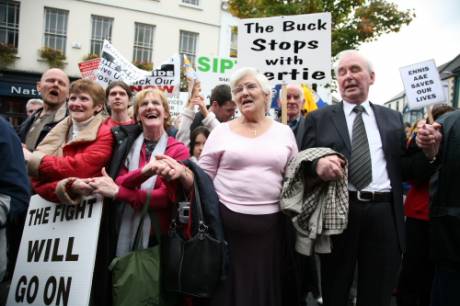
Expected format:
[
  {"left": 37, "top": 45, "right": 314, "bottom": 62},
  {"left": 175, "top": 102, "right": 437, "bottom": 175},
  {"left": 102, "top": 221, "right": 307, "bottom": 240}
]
[{"left": 195, "top": 55, "right": 236, "bottom": 104}]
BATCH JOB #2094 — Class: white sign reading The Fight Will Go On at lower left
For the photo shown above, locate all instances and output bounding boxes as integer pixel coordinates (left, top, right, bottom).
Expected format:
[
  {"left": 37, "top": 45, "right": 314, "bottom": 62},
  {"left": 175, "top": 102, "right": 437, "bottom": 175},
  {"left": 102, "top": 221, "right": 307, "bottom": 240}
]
[{"left": 7, "top": 195, "right": 102, "bottom": 306}]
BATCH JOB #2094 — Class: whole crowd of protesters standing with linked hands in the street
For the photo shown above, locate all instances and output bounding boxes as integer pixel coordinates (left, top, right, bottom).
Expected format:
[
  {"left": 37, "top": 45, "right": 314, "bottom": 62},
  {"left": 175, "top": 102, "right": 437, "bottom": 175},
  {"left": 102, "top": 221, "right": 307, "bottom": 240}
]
[{"left": 0, "top": 50, "right": 460, "bottom": 306}]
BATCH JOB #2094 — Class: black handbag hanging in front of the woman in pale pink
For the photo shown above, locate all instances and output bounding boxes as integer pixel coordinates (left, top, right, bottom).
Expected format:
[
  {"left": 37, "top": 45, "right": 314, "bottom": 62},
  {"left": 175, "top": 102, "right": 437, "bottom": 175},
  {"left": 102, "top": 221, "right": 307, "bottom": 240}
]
[{"left": 161, "top": 182, "right": 226, "bottom": 298}]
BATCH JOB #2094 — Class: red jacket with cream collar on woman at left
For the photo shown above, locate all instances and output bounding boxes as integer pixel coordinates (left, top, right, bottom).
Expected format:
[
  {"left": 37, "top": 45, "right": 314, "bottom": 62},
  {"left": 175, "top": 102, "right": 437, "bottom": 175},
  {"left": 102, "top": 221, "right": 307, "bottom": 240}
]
[{"left": 31, "top": 115, "right": 113, "bottom": 203}]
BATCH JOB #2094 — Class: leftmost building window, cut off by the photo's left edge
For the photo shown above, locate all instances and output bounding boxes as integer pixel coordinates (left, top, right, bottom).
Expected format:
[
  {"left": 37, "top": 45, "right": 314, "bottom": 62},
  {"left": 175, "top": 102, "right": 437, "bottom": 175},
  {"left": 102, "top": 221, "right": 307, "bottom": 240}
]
[{"left": 0, "top": 1, "right": 19, "bottom": 48}]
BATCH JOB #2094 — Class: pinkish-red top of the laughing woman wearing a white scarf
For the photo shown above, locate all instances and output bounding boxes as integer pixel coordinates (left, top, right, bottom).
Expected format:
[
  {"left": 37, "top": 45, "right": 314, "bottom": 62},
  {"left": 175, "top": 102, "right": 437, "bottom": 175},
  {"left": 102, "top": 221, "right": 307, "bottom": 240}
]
[{"left": 115, "top": 137, "right": 189, "bottom": 233}]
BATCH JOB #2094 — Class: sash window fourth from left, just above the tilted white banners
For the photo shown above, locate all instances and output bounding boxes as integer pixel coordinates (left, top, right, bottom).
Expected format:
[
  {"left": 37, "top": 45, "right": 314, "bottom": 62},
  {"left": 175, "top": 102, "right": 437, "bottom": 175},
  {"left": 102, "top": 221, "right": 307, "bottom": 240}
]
[{"left": 133, "top": 22, "right": 155, "bottom": 63}]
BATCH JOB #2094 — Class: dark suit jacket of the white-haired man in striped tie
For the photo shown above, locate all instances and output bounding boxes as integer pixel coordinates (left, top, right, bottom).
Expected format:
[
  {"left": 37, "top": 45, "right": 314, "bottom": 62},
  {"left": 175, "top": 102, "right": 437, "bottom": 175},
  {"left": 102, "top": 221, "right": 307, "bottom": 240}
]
[{"left": 300, "top": 103, "right": 435, "bottom": 251}]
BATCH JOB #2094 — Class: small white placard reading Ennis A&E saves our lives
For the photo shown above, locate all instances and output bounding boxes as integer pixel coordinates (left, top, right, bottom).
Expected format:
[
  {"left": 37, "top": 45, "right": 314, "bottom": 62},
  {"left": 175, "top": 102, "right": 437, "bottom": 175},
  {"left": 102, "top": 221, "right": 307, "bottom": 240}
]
[{"left": 399, "top": 60, "right": 446, "bottom": 109}]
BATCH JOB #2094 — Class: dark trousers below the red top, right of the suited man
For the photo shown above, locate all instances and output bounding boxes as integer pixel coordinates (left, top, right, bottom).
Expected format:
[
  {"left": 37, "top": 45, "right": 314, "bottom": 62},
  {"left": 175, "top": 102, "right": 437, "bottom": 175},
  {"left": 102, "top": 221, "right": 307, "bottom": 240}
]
[{"left": 397, "top": 217, "right": 434, "bottom": 306}]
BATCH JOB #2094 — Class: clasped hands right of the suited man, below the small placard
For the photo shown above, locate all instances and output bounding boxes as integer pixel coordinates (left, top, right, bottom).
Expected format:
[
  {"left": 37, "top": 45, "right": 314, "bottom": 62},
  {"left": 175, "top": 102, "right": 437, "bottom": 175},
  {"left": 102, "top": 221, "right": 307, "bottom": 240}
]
[{"left": 415, "top": 122, "right": 442, "bottom": 160}]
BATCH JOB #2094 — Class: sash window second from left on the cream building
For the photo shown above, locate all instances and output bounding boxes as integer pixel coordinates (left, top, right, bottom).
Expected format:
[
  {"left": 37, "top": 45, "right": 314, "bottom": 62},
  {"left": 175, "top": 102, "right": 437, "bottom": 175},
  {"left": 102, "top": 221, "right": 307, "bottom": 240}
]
[{"left": 44, "top": 7, "right": 69, "bottom": 54}]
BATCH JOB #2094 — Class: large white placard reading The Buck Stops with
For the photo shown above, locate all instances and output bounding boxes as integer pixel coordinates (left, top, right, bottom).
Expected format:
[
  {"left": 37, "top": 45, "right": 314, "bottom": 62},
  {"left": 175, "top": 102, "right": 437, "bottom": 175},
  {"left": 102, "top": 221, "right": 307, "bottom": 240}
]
[{"left": 238, "top": 13, "right": 331, "bottom": 84}]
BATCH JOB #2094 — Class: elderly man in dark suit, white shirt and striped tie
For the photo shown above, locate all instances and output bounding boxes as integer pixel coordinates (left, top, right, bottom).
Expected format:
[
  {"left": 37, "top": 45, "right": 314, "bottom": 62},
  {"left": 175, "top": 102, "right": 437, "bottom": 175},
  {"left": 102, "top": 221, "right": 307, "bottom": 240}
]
[{"left": 301, "top": 50, "right": 435, "bottom": 306}]
